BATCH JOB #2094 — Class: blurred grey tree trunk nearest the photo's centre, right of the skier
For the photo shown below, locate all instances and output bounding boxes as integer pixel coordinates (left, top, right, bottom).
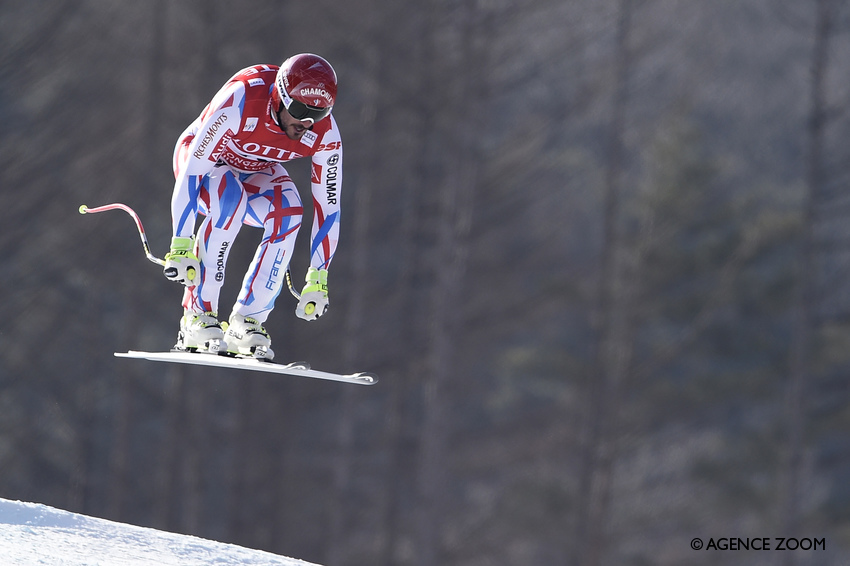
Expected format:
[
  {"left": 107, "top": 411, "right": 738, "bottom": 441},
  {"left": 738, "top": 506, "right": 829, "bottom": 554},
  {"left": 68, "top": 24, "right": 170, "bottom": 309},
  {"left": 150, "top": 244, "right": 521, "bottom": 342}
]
[{"left": 416, "top": 2, "right": 486, "bottom": 566}]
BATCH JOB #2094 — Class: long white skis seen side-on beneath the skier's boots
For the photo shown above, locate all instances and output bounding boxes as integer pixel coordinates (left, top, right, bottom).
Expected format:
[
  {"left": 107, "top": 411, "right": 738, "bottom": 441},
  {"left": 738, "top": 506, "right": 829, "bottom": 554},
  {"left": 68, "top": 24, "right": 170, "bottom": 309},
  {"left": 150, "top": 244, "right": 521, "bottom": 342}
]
[{"left": 115, "top": 350, "right": 378, "bottom": 385}]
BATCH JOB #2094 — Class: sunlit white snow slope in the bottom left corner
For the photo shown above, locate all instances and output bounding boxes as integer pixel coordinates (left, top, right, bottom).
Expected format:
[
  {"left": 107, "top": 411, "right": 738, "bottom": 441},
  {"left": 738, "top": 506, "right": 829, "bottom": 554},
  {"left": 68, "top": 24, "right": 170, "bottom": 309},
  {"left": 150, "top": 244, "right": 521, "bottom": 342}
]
[{"left": 0, "top": 499, "right": 315, "bottom": 566}]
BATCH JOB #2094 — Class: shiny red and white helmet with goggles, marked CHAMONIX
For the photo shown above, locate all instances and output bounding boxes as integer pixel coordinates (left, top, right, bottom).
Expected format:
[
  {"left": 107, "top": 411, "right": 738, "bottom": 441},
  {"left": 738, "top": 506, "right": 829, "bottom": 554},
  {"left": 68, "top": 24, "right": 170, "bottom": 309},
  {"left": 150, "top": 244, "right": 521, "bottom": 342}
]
[{"left": 272, "top": 53, "right": 336, "bottom": 123}]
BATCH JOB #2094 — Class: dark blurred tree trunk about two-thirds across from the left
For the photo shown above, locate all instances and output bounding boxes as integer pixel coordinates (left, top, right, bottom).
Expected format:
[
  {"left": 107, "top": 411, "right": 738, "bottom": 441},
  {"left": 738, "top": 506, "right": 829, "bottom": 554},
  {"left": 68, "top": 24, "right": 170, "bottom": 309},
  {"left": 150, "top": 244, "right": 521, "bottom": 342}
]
[{"left": 571, "top": 0, "right": 634, "bottom": 566}]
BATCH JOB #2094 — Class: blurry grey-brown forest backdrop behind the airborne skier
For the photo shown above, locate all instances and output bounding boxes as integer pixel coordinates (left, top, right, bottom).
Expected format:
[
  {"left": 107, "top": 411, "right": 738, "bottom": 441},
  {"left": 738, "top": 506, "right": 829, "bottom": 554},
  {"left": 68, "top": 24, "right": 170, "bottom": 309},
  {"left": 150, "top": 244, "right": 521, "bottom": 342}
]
[{"left": 0, "top": 0, "right": 850, "bottom": 566}]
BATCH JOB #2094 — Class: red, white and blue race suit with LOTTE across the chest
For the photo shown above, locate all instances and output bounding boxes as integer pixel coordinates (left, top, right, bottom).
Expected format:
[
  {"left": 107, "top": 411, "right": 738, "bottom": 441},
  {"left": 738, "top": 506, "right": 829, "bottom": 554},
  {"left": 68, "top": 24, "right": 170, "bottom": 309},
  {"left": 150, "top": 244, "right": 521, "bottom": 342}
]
[{"left": 171, "top": 65, "right": 342, "bottom": 322}]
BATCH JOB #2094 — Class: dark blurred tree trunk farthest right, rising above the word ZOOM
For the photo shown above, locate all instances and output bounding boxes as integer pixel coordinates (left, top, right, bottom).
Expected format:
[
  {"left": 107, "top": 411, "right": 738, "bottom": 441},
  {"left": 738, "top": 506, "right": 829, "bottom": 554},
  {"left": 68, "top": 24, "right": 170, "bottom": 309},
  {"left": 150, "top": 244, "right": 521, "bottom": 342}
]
[{"left": 782, "top": 0, "right": 835, "bottom": 566}]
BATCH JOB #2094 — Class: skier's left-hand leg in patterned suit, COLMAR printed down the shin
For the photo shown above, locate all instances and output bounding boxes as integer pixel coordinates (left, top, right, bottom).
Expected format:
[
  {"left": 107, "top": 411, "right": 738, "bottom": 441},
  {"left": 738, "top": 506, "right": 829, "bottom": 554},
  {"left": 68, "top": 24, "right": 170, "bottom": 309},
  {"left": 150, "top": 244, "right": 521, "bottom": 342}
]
[{"left": 183, "top": 167, "right": 247, "bottom": 320}]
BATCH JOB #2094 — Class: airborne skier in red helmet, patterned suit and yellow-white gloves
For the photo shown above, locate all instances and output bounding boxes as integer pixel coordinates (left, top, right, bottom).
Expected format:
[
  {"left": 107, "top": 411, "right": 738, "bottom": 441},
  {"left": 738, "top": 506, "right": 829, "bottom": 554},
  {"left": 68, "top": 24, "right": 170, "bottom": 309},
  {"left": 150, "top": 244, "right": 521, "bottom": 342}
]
[{"left": 163, "top": 53, "right": 342, "bottom": 360}]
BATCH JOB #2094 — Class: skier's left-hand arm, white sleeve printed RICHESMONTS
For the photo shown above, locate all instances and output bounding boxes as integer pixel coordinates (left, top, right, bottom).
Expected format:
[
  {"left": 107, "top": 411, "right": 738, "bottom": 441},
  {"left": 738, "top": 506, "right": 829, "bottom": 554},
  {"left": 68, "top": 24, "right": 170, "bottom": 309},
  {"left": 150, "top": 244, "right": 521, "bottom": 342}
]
[{"left": 171, "top": 81, "right": 245, "bottom": 238}]
